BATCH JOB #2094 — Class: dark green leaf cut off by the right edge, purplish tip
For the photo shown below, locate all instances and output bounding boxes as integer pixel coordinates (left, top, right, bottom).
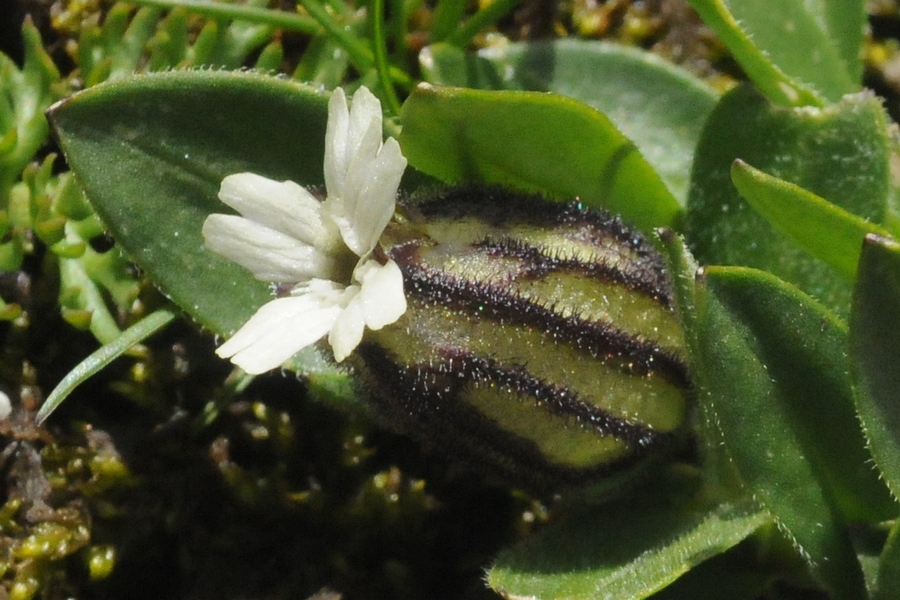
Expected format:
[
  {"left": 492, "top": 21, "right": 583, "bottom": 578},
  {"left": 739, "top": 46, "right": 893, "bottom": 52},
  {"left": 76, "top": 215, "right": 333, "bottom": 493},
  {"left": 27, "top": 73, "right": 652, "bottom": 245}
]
[{"left": 850, "top": 236, "right": 900, "bottom": 498}]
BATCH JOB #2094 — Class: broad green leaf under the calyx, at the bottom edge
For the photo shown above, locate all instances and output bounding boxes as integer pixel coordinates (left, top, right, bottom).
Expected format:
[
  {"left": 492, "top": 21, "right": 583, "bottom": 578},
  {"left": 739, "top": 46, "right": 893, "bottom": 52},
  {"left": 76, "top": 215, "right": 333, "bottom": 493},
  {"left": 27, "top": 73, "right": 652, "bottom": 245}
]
[{"left": 488, "top": 478, "right": 770, "bottom": 600}]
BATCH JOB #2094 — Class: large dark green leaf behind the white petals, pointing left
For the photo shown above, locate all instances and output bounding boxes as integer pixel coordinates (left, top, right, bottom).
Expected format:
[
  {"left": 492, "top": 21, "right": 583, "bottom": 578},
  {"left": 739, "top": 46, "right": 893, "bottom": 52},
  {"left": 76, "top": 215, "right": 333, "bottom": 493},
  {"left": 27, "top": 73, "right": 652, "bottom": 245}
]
[{"left": 49, "top": 71, "right": 345, "bottom": 392}]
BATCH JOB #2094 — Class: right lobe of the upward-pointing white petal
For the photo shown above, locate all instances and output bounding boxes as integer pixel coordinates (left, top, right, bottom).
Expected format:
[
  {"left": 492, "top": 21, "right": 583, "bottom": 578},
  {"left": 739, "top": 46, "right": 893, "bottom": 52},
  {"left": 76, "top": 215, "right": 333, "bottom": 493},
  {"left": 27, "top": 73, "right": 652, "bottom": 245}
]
[{"left": 334, "top": 138, "right": 406, "bottom": 256}]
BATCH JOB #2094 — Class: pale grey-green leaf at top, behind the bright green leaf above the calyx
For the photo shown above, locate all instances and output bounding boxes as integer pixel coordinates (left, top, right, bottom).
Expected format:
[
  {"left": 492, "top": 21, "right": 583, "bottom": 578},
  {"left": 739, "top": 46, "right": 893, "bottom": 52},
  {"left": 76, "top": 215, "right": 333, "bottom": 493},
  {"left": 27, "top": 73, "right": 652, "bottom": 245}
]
[{"left": 419, "top": 39, "right": 717, "bottom": 204}]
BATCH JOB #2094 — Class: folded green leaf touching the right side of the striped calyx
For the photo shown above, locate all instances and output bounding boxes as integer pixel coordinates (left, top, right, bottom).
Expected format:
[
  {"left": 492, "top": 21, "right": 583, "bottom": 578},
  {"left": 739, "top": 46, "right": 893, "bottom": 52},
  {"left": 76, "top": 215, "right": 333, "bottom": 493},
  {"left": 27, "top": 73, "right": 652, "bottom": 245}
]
[{"left": 695, "top": 267, "right": 880, "bottom": 600}]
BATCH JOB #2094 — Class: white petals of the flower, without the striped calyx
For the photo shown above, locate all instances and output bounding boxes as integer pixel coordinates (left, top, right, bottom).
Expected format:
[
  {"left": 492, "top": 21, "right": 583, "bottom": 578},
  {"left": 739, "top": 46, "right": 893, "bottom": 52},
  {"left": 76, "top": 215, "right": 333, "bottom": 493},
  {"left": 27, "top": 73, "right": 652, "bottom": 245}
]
[{"left": 203, "top": 87, "right": 406, "bottom": 374}]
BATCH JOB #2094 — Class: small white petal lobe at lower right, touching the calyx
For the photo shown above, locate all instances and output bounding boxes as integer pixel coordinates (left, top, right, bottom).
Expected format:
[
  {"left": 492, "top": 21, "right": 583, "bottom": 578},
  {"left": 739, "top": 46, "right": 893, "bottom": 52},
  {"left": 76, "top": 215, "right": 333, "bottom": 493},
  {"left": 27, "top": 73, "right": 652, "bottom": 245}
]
[{"left": 353, "top": 259, "right": 406, "bottom": 329}]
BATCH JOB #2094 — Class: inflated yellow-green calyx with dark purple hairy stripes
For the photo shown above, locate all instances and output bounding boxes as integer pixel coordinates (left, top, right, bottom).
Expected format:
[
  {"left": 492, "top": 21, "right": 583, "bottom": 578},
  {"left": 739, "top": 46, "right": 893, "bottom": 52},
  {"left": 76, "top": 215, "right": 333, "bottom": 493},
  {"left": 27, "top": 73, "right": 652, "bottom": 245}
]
[{"left": 355, "top": 187, "right": 690, "bottom": 489}]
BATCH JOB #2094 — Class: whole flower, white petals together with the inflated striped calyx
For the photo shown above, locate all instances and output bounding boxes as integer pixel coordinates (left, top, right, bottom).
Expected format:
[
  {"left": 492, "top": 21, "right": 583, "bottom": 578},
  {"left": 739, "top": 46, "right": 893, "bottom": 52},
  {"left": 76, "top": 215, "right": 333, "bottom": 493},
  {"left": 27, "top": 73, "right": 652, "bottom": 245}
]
[{"left": 203, "top": 83, "right": 690, "bottom": 490}]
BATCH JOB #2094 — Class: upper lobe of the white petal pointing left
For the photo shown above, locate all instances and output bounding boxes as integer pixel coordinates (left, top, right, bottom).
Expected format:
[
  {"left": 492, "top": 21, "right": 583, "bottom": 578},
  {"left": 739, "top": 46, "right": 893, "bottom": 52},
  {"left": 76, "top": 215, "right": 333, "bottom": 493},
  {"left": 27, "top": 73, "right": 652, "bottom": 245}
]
[{"left": 219, "top": 173, "right": 339, "bottom": 250}]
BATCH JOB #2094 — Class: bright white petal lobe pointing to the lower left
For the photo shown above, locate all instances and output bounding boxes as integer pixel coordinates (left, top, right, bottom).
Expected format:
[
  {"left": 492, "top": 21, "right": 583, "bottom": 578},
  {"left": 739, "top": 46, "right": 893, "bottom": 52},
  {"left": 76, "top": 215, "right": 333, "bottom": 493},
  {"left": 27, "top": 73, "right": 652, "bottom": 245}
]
[{"left": 216, "top": 294, "right": 341, "bottom": 375}]
